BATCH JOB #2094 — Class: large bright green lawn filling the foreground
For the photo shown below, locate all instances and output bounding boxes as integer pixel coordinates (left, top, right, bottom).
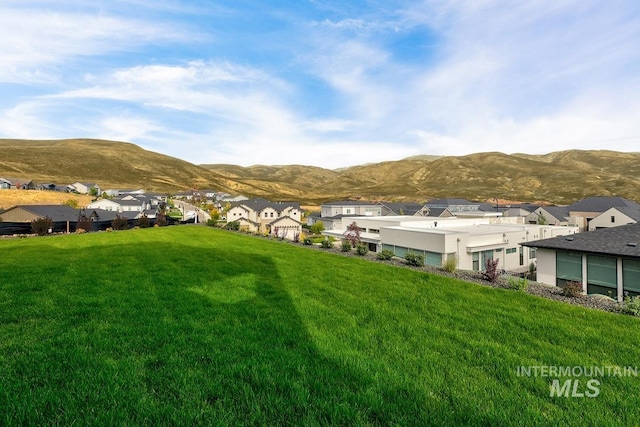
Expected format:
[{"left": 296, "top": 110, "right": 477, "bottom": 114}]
[{"left": 0, "top": 226, "right": 640, "bottom": 426}]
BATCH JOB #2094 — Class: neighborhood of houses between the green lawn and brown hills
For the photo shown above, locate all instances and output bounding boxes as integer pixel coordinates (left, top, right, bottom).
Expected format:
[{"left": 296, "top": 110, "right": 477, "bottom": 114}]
[{"left": 0, "top": 177, "right": 640, "bottom": 300}]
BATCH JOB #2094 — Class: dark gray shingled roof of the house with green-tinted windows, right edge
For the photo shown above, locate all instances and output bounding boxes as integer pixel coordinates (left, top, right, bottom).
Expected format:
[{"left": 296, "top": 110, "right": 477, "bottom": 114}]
[{"left": 522, "top": 223, "right": 640, "bottom": 258}]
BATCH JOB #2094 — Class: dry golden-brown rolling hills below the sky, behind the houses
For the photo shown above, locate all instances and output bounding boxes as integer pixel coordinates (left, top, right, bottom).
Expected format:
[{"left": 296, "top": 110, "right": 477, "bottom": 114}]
[{"left": 0, "top": 139, "right": 640, "bottom": 204}]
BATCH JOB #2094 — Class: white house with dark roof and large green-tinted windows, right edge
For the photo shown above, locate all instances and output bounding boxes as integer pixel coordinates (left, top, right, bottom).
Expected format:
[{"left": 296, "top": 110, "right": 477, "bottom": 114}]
[{"left": 522, "top": 223, "right": 640, "bottom": 301}]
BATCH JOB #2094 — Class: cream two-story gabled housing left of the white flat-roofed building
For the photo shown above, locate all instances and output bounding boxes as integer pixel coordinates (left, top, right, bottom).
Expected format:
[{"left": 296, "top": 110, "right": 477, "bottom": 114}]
[{"left": 226, "top": 198, "right": 302, "bottom": 239}]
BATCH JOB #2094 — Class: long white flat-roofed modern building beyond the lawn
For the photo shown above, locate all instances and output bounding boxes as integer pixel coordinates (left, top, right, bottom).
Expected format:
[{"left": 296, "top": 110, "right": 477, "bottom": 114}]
[{"left": 323, "top": 216, "right": 578, "bottom": 273}]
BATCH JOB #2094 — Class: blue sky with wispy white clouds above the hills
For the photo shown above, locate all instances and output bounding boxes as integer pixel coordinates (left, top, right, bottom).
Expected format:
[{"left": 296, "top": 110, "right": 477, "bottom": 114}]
[{"left": 0, "top": 0, "right": 640, "bottom": 168}]
